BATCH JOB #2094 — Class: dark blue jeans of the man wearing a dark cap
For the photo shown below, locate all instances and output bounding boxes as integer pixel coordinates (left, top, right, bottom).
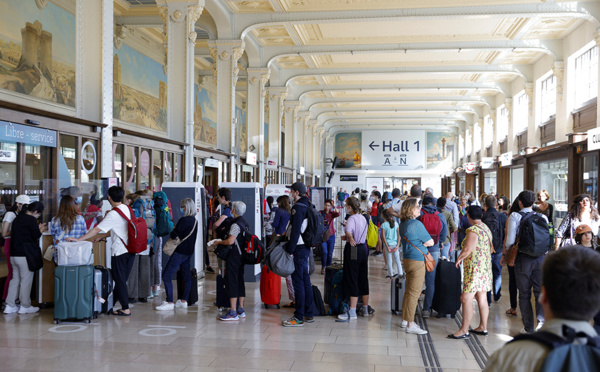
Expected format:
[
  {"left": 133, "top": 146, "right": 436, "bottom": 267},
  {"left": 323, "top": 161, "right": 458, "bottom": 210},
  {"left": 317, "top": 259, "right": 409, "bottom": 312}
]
[{"left": 292, "top": 245, "right": 313, "bottom": 320}]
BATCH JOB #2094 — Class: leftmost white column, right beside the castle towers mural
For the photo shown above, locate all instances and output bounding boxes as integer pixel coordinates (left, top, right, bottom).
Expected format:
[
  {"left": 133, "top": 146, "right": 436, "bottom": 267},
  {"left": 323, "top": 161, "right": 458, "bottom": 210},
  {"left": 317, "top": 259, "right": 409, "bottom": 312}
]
[{"left": 75, "top": 0, "right": 114, "bottom": 177}]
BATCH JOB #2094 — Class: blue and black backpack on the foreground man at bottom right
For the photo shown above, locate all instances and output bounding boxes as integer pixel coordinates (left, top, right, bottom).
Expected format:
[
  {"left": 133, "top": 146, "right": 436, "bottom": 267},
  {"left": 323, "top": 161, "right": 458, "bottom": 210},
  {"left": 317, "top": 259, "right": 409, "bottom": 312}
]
[{"left": 510, "top": 325, "right": 600, "bottom": 372}]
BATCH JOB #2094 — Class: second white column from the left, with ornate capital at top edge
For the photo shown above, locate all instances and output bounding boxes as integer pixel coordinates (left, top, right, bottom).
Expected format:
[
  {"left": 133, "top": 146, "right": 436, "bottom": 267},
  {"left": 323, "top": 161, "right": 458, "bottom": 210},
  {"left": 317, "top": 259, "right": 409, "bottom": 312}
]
[{"left": 157, "top": 0, "right": 204, "bottom": 182}]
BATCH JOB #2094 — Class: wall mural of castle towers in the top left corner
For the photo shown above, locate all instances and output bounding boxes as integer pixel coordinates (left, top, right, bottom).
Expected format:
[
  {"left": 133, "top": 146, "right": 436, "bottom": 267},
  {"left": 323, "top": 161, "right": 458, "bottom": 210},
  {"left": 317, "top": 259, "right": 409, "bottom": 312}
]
[{"left": 0, "top": 0, "right": 76, "bottom": 107}]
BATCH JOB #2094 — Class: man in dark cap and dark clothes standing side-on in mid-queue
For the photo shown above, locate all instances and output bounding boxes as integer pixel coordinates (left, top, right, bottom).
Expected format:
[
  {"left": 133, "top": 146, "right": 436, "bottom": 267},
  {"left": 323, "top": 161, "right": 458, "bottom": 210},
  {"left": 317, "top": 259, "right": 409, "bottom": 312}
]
[{"left": 282, "top": 182, "right": 315, "bottom": 327}]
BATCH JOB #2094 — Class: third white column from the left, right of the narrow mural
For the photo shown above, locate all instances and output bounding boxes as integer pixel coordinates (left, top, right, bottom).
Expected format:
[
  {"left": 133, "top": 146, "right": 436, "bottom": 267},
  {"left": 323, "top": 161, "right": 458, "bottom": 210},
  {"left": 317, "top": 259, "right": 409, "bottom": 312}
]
[{"left": 208, "top": 40, "right": 244, "bottom": 182}]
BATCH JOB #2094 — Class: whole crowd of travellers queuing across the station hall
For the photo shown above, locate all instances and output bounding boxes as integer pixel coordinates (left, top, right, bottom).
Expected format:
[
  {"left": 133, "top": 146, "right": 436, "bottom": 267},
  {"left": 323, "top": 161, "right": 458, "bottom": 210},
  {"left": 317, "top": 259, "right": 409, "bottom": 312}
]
[{"left": 2, "top": 182, "right": 600, "bottom": 370}]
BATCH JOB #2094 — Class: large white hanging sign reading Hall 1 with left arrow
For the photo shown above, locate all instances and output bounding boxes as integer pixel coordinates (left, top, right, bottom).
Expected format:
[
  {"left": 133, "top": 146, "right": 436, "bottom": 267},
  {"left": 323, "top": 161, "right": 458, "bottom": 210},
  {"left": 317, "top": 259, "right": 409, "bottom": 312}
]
[{"left": 358, "top": 130, "right": 426, "bottom": 171}]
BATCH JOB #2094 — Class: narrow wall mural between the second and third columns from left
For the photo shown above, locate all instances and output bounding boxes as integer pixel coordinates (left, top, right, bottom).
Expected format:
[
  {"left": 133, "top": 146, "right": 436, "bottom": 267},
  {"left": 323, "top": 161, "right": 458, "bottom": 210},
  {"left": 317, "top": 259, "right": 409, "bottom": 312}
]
[{"left": 194, "top": 84, "right": 217, "bottom": 146}]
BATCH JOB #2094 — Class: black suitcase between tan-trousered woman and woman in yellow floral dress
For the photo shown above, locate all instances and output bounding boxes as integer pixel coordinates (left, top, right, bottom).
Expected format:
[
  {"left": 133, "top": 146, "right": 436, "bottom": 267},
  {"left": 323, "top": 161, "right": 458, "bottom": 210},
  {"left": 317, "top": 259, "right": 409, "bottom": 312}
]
[{"left": 431, "top": 260, "right": 462, "bottom": 318}]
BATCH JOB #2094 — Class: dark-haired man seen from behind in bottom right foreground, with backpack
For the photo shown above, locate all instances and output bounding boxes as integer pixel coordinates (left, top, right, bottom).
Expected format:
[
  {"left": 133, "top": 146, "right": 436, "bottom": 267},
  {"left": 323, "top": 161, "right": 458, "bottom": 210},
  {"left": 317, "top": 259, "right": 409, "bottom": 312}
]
[{"left": 485, "top": 246, "right": 600, "bottom": 372}]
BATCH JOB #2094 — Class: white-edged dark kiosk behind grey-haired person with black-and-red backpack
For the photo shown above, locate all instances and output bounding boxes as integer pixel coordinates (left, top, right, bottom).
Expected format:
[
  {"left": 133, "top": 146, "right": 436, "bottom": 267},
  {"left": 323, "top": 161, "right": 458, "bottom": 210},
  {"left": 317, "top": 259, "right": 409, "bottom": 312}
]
[{"left": 219, "top": 182, "right": 265, "bottom": 282}]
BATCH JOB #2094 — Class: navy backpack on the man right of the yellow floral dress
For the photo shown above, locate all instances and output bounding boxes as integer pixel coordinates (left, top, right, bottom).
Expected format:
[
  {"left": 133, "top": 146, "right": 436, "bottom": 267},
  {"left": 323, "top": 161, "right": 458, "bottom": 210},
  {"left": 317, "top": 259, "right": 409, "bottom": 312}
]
[{"left": 518, "top": 212, "right": 552, "bottom": 257}]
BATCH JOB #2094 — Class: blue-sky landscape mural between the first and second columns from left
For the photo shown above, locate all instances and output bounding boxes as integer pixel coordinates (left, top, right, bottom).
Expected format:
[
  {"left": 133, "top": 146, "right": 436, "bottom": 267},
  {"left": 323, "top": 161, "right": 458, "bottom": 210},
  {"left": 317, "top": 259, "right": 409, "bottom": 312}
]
[{"left": 113, "top": 44, "right": 167, "bottom": 132}]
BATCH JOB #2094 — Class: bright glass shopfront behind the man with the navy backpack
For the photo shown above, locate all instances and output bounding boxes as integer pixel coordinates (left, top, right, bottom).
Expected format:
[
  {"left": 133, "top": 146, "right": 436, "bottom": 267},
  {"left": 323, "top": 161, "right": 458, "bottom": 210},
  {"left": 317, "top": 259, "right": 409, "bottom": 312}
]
[{"left": 533, "top": 158, "right": 569, "bottom": 226}]
